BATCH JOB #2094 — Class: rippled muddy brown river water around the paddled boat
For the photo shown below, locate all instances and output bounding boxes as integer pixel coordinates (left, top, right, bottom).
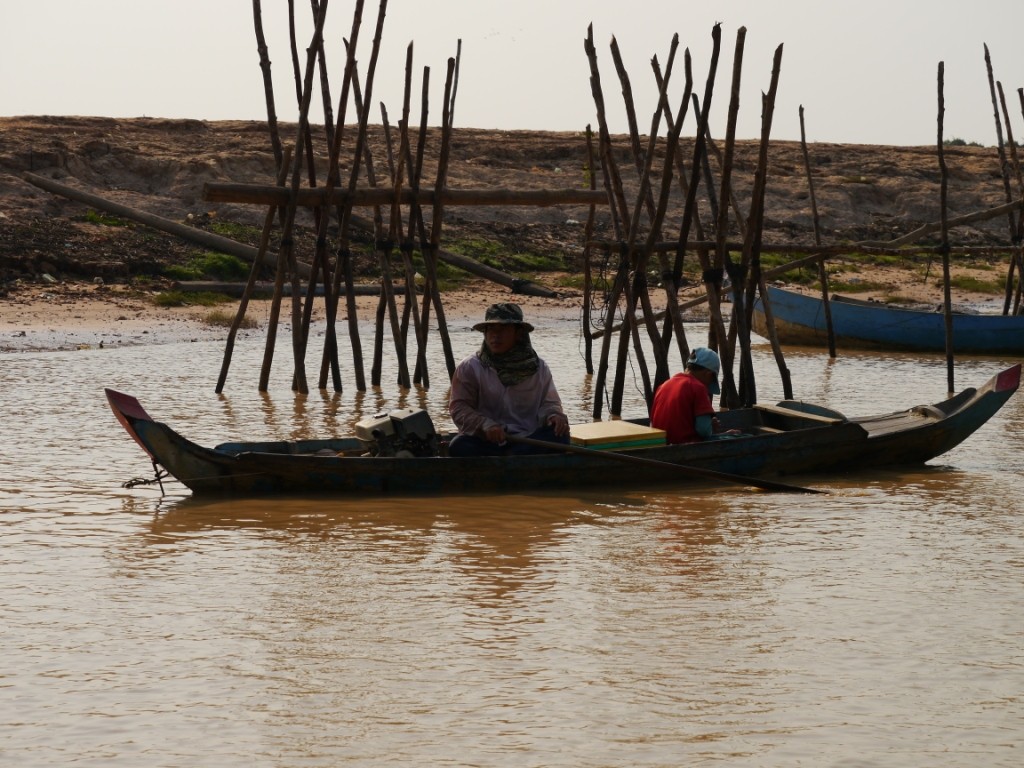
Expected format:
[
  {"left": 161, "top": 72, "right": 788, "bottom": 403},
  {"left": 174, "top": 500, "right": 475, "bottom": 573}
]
[{"left": 0, "top": 315, "right": 1024, "bottom": 768}]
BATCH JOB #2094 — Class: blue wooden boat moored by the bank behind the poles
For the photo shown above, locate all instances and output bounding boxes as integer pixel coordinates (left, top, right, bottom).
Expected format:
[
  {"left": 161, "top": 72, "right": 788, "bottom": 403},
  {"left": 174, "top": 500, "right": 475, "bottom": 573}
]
[{"left": 753, "top": 288, "right": 1024, "bottom": 354}]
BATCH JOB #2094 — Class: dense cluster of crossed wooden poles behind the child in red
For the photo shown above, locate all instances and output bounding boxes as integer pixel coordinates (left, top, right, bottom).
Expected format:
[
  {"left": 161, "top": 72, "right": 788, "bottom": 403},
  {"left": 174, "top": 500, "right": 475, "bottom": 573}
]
[{"left": 584, "top": 25, "right": 788, "bottom": 418}]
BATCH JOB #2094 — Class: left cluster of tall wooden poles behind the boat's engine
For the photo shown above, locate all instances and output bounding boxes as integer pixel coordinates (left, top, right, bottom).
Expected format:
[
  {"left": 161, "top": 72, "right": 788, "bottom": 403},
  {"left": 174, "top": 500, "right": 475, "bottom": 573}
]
[{"left": 217, "top": 0, "right": 475, "bottom": 393}]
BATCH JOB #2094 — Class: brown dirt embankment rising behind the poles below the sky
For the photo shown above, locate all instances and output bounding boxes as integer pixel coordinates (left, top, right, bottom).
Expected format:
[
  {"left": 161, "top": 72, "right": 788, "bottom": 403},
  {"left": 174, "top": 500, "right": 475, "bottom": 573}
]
[{"left": 0, "top": 117, "right": 1008, "bottom": 296}]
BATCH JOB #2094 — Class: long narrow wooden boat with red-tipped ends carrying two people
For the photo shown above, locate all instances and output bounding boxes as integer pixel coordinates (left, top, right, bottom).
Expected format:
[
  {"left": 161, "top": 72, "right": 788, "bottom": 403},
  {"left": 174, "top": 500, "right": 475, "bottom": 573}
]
[{"left": 106, "top": 365, "right": 1021, "bottom": 497}]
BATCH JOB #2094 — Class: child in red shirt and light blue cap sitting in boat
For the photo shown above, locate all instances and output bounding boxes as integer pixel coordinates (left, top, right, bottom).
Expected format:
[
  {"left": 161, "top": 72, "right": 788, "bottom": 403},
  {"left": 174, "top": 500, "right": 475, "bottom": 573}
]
[{"left": 650, "top": 347, "right": 740, "bottom": 444}]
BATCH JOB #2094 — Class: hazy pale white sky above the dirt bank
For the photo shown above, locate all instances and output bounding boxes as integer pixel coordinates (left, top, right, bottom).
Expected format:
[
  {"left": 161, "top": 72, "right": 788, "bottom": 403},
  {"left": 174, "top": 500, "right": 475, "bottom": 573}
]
[{"left": 0, "top": 0, "right": 1024, "bottom": 145}]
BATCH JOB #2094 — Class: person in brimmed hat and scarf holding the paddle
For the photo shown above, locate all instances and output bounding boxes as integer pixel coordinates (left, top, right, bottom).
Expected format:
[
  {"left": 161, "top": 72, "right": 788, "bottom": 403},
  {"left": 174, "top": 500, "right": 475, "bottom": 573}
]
[{"left": 449, "top": 303, "right": 569, "bottom": 456}]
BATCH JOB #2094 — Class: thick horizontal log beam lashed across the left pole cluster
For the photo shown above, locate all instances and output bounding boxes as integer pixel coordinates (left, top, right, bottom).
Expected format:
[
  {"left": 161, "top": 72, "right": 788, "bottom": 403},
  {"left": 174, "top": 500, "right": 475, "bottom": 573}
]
[{"left": 203, "top": 182, "right": 608, "bottom": 208}]
